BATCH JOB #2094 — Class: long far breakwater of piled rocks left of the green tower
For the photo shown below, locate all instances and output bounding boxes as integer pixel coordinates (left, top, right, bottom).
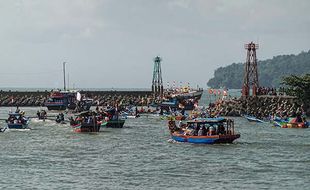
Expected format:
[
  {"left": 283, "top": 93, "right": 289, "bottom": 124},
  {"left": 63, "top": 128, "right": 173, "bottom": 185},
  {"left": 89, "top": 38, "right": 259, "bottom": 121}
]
[{"left": 0, "top": 90, "right": 153, "bottom": 106}]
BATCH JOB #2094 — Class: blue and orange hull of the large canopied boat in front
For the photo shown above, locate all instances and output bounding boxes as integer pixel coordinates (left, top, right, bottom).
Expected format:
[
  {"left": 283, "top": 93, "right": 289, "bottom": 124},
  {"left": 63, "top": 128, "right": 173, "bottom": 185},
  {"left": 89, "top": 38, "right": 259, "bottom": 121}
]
[{"left": 171, "top": 133, "right": 240, "bottom": 144}]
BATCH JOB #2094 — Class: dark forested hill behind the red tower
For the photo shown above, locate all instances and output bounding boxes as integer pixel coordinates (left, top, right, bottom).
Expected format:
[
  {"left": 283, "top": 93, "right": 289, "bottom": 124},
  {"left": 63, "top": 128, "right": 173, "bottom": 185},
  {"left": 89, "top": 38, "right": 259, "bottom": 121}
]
[{"left": 207, "top": 50, "right": 310, "bottom": 89}]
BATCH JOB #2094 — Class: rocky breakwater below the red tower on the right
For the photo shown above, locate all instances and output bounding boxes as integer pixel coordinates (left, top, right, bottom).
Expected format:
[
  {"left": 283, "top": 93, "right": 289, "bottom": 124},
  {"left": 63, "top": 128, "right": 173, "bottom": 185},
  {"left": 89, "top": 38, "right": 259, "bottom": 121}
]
[{"left": 209, "top": 96, "right": 310, "bottom": 118}]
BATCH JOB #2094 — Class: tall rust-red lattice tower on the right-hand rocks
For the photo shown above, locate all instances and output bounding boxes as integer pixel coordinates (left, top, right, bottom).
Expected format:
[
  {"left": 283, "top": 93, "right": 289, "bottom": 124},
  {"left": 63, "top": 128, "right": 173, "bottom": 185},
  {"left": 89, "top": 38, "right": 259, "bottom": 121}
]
[{"left": 242, "top": 42, "right": 259, "bottom": 97}]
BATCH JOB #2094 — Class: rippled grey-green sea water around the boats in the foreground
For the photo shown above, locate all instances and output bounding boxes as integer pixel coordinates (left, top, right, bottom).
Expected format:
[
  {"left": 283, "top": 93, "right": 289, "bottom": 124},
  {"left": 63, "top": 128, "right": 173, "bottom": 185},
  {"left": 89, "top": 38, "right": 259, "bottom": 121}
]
[{"left": 0, "top": 107, "right": 310, "bottom": 189}]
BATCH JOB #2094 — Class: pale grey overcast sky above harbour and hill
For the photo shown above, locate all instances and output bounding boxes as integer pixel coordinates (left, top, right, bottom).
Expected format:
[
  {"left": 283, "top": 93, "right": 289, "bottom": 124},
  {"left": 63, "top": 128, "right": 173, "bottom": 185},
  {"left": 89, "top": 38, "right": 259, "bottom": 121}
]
[{"left": 0, "top": 0, "right": 310, "bottom": 88}]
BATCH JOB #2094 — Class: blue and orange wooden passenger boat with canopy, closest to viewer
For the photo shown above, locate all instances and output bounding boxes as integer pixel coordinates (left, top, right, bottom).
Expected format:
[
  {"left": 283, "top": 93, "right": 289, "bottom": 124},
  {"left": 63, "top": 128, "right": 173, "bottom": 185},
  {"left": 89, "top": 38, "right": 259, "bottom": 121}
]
[{"left": 169, "top": 118, "right": 240, "bottom": 144}]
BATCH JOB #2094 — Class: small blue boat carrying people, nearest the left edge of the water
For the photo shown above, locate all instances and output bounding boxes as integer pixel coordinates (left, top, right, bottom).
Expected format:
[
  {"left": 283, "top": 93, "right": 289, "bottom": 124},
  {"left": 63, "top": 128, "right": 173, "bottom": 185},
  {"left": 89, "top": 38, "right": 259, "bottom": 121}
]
[{"left": 7, "top": 113, "right": 30, "bottom": 129}]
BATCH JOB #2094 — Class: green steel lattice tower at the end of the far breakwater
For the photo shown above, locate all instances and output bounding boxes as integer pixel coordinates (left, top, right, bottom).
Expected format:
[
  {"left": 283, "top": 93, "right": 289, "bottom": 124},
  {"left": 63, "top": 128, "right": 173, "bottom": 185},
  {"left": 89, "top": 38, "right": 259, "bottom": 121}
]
[{"left": 152, "top": 56, "right": 164, "bottom": 96}]
